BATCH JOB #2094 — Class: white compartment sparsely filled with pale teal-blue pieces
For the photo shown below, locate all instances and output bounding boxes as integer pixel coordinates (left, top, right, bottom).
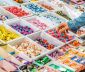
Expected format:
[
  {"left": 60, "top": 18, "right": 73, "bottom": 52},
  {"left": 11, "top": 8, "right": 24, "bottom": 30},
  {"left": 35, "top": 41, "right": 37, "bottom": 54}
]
[{"left": 40, "top": 12, "right": 67, "bottom": 26}]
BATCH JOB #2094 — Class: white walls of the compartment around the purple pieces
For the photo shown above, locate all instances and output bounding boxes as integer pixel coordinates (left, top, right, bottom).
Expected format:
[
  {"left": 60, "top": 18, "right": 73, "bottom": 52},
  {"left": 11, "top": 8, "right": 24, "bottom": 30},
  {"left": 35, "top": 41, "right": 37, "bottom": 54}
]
[{"left": 5, "top": 18, "right": 39, "bottom": 35}]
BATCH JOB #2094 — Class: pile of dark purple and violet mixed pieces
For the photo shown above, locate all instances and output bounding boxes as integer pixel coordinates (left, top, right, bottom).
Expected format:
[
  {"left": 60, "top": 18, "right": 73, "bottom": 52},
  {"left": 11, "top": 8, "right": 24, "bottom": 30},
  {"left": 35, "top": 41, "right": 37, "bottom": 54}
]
[{"left": 11, "top": 24, "right": 34, "bottom": 35}]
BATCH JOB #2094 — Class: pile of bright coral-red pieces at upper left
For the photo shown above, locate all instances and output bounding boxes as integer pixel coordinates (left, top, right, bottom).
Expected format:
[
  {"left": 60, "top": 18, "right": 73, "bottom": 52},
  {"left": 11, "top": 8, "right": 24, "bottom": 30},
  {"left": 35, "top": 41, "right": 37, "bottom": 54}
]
[{"left": 5, "top": 6, "right": 29, "bottom": 17}]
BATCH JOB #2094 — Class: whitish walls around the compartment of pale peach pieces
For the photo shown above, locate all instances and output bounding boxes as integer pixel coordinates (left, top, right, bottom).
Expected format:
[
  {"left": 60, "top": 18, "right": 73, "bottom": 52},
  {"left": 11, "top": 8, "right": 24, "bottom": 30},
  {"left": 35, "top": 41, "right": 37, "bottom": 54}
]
[{"left": 9, "top": 37, "right": 48, "bottom": 61}]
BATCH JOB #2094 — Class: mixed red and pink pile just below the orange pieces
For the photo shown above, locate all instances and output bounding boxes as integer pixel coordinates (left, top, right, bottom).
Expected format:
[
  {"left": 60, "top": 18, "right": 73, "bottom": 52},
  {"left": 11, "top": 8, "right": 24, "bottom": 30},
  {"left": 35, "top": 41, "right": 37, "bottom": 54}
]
[{"left": 47, "top": 28, "right": 74, "bottom": 43}]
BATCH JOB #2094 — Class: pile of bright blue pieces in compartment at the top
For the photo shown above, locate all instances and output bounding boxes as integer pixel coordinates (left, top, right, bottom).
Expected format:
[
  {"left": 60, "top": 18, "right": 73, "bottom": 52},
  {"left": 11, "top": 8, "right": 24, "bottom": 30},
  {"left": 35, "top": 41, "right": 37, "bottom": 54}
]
[{"left": 25, "top": 3, "right": 46, "bottom": 13}]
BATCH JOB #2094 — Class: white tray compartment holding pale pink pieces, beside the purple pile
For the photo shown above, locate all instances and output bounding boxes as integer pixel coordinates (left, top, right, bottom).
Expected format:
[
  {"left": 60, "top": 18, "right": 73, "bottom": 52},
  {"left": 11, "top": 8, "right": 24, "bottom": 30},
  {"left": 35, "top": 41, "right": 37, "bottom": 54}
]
[{"left": 23, "top": 16, "right": 54, "bottom": 30}]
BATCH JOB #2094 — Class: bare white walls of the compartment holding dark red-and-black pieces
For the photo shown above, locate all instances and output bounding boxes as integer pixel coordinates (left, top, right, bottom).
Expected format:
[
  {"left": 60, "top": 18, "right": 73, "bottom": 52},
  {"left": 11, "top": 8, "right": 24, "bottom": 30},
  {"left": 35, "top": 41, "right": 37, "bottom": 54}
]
[{"left": 28, "top": 32, "right": 63, "bottom": 50}]
